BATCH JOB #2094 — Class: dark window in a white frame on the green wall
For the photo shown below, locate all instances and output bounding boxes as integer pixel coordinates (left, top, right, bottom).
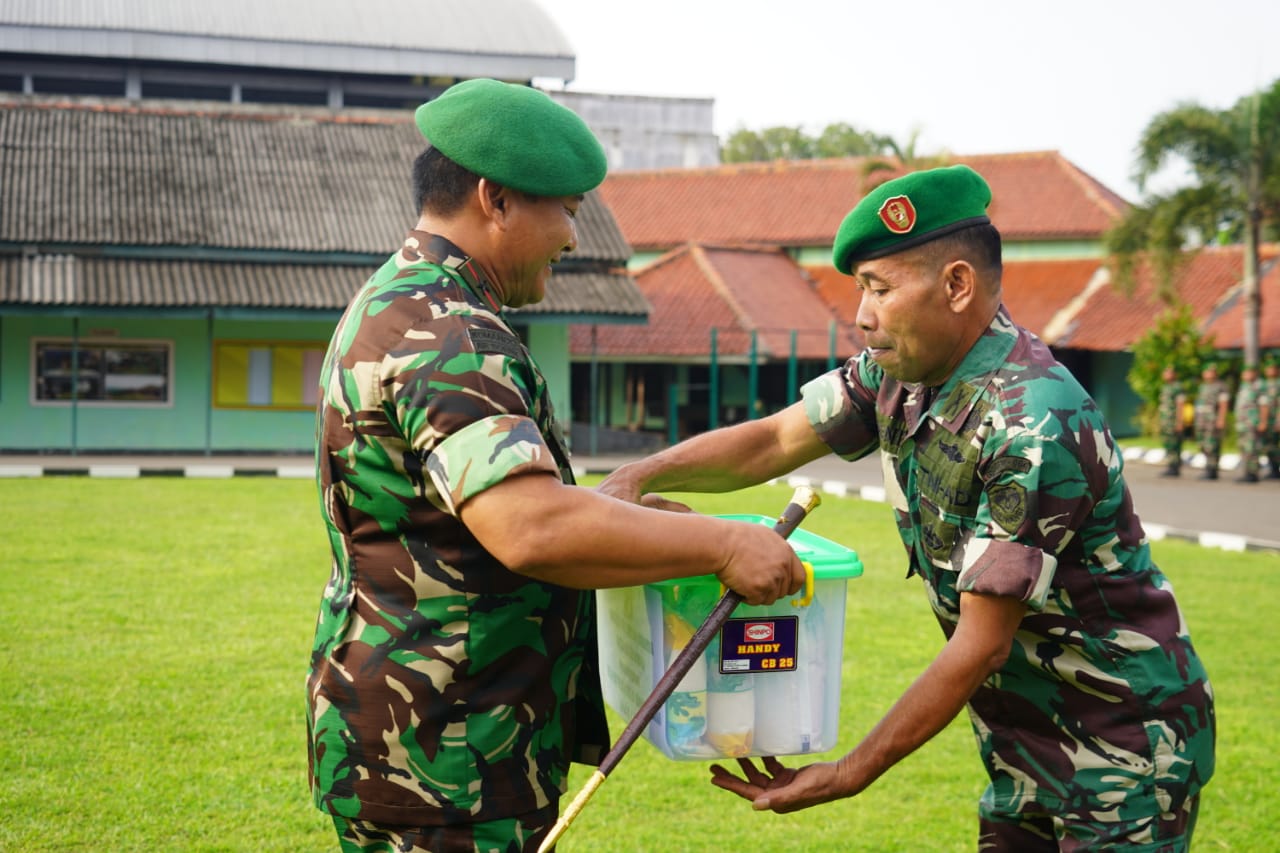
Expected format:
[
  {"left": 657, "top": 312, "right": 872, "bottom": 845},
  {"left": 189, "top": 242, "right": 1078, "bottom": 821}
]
[{"left": 32, "top": 339, "right": 173, "bottom": 405}]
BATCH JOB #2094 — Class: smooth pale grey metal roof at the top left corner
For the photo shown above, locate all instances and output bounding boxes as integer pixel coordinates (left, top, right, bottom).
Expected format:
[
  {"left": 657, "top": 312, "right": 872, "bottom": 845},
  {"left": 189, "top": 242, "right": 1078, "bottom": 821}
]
[{"left": 0, "top": 0, "right": 573, "bottom": 81}]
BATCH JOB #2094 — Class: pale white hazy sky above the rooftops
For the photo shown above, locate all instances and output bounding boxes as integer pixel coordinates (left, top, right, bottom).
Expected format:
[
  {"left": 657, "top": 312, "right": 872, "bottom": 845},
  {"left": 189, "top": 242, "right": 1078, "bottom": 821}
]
[{"left": 536, "top": 0, "right": 1280, "bottom": 201}]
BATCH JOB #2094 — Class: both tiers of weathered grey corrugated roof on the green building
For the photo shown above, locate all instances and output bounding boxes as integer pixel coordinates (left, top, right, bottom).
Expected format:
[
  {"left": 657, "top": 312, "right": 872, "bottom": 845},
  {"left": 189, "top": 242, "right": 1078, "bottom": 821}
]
[{"left": 0, "top": 95, "right": 649, "bottom": 321}]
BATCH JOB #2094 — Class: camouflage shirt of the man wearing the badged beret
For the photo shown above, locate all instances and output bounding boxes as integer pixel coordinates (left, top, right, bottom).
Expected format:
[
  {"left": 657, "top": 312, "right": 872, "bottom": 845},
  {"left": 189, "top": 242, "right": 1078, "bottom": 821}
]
[{"left": 803, "top": 309, "right": 1215, "bottom": 820}]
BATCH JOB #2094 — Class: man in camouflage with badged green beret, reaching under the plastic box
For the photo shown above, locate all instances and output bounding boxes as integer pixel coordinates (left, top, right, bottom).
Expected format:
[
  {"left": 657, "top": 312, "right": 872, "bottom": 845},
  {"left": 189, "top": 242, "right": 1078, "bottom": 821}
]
[{"left": 602, "top": 167, "right": 1215, "bottom": 853}]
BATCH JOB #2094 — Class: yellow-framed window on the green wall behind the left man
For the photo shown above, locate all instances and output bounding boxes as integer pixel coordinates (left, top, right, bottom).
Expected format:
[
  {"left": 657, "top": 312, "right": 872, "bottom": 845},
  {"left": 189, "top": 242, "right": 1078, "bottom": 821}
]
[{"left": 214, "top": 341, "right": 325, "bottom": 409}]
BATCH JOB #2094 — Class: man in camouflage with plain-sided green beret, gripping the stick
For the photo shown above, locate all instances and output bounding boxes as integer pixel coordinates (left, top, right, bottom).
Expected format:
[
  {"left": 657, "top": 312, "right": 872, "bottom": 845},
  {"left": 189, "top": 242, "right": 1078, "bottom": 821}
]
[{"left": 307, "top": 79, "right": 804, "bottom": 853}]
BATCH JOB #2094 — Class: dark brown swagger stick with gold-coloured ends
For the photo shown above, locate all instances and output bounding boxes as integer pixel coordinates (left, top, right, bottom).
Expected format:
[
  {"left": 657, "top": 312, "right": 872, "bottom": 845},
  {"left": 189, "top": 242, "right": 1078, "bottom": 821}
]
[{"left": 538, "top": 485, "right": 820, "bottom": 853}]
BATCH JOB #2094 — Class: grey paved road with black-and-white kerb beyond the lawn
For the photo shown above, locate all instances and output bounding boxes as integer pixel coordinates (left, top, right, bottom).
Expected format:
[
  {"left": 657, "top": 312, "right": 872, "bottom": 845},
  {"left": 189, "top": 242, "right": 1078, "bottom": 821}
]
[{"left": 0, "top": 445, "right": 1280, "bottom": 553}]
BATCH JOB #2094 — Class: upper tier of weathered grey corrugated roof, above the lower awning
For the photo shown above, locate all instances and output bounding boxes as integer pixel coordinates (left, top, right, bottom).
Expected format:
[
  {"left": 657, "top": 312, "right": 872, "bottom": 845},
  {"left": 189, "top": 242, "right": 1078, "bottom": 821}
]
[{"left": 0, "top": 95, "right": 631, "bottom": 258}]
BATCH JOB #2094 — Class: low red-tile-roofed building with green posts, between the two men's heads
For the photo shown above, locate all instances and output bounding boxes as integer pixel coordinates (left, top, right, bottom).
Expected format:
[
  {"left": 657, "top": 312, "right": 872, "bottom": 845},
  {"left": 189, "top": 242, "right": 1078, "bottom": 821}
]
[{"left": 570, "top": 243, "right": 861, "bottom": 434}]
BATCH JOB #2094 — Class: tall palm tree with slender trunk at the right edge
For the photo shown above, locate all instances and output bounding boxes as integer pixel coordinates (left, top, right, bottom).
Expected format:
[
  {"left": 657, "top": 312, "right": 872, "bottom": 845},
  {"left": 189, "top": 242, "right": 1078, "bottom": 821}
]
[{"left": 1105, "top": 81, "right": 1280, "bottom": 365}]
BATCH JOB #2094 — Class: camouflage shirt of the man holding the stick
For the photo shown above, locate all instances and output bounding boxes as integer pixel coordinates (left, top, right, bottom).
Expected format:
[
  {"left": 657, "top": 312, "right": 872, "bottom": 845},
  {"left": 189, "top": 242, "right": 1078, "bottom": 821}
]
[{"left": 307, "top": 232, "right": 608, "bottom": 825}]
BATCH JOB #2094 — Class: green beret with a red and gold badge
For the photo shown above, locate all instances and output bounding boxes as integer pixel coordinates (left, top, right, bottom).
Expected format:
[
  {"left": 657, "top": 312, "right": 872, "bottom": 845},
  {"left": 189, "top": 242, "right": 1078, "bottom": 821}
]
[{"left": 832, "top": 165, "right": 991, "bottom": 275}]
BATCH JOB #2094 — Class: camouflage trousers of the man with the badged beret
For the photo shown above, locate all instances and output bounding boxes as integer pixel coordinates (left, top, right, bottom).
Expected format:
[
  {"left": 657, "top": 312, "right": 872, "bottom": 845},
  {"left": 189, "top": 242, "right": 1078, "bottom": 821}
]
[{"left": 978, "top": 794, "right": 1199, "bottom": 853}]
